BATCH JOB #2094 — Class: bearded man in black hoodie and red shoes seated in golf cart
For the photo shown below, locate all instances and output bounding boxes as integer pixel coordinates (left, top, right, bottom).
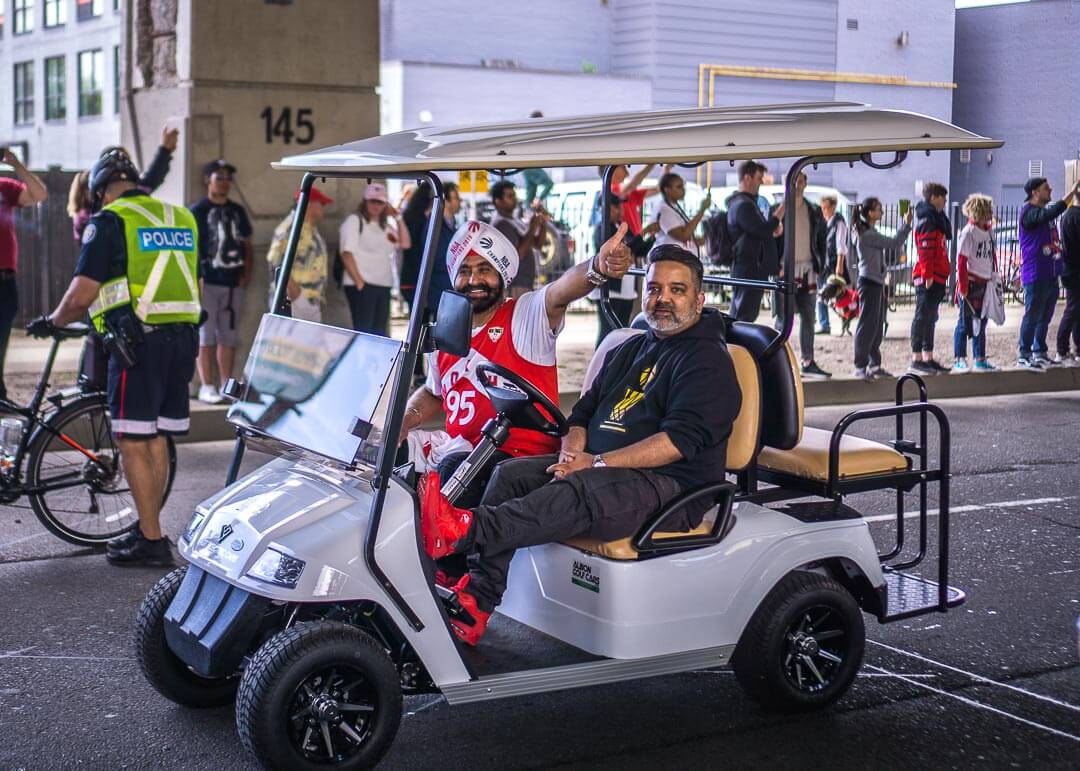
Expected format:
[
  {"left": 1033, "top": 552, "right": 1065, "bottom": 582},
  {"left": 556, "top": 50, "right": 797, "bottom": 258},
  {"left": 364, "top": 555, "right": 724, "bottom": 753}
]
[{"left": 419, "top": 244, "right": 742, "bottom": 645}]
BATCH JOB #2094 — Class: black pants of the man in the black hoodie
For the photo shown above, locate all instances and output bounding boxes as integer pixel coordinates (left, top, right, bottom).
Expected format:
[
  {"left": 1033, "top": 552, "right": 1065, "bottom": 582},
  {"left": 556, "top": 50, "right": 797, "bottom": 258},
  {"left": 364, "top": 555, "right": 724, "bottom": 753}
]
[{"left": 458, "top": 455, "right": 678, "bottom": 612}]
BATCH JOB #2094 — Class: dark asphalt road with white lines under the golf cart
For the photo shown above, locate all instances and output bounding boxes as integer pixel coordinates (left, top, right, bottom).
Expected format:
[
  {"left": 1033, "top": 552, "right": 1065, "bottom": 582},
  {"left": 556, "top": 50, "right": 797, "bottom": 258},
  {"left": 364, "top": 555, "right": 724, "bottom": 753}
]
[{"left": 0, "top": 393, "right": 1080, "bottom": 771}]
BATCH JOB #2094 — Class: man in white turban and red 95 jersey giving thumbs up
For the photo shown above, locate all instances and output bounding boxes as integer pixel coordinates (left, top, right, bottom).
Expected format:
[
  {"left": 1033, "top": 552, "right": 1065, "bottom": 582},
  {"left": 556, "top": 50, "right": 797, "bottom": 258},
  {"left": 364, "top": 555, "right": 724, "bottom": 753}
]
[{"left": 401, "top": 212, "right": 633, "bottom": 571}]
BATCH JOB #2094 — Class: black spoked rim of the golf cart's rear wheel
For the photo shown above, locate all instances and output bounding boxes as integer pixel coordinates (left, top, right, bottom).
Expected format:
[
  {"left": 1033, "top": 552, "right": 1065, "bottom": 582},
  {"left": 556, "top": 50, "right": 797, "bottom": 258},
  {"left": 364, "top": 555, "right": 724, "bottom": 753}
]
[{"left": 781, "top": 605, "right": 850, "bottom": 693}]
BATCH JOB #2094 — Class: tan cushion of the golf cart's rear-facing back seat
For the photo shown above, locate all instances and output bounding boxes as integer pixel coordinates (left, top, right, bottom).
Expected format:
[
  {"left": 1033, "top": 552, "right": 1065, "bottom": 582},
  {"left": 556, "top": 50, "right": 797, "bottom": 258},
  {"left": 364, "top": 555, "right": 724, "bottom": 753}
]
[{"left": 757, "top": 427, "right": 907, "bottom": 482}]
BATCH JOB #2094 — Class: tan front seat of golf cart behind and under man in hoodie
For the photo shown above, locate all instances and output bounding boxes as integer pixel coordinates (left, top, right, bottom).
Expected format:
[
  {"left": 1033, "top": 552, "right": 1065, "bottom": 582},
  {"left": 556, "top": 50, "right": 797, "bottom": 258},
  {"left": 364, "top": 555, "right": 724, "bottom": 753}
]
[{"left": 566, "top": 317, "right": 761, "bottom": 559}]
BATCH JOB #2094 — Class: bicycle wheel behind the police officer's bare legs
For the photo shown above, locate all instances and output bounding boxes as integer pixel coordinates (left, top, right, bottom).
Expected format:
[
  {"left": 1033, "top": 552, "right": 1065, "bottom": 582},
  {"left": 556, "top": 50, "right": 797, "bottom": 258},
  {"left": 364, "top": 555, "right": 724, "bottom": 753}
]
[{"left": 27, "top": 397, "right": 176, "bottom": 546}]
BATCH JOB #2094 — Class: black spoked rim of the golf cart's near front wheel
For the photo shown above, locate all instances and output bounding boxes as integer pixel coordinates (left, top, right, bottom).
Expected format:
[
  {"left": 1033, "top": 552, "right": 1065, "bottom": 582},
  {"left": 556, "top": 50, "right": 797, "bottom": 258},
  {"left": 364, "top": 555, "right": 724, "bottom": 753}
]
[{"left": 287, "top": 664, "right": 377, "bottom": 766}]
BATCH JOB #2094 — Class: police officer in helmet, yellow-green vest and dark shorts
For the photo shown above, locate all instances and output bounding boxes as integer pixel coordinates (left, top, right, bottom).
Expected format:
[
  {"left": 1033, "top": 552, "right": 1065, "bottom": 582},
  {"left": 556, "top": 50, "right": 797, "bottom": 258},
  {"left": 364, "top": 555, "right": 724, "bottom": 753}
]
[{"left": 27, "top": 149, "right": 201, "bottom": 566}]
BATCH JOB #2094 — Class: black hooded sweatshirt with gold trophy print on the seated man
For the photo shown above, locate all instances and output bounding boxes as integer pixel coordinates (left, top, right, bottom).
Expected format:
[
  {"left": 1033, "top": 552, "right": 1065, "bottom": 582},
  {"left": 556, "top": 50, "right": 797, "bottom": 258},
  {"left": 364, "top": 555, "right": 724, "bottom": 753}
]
[{"left": 569, "top": 308, "right": 742, "bottom": 526}]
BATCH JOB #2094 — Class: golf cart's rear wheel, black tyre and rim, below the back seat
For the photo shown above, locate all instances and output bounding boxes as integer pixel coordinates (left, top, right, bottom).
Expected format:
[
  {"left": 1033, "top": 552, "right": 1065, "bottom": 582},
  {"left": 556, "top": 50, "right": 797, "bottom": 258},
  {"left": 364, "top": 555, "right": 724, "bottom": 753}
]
[{"left": 731, "top": 570, "right": 866, "bottom": 712}]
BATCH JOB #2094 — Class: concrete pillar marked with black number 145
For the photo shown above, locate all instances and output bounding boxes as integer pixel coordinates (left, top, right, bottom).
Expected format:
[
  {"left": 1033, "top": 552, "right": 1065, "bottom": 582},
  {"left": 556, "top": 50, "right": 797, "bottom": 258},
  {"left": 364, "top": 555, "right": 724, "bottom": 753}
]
[{"left": 121, "top": 0, "right": 379, "bottom": 371}]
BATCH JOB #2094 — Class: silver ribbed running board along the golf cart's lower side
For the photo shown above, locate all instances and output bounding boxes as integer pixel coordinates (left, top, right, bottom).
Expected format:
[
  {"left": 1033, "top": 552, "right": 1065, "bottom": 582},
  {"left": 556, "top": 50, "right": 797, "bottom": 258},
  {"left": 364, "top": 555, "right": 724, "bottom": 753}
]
[{"left": 442, "top": 645, "right": 735, "bottom": 704}]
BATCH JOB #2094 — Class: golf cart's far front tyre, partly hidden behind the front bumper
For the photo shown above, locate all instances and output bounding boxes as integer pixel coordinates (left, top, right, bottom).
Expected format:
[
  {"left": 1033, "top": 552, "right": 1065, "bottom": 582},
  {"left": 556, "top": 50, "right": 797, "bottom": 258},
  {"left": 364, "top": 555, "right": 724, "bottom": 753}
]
[{"left": 135, "top": 566, "right": 240, "bottom": 707}]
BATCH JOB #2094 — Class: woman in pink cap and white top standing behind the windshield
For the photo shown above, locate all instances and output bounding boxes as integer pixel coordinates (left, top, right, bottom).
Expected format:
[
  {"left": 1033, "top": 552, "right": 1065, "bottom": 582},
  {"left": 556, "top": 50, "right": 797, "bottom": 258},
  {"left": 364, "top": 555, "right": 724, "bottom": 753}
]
[{"left": 338, "top": 182, "right": 411, "bottom": 336}]
